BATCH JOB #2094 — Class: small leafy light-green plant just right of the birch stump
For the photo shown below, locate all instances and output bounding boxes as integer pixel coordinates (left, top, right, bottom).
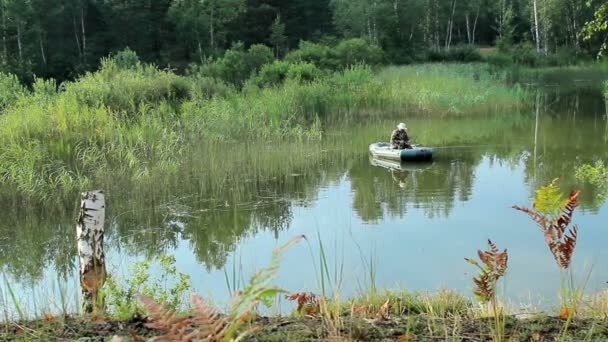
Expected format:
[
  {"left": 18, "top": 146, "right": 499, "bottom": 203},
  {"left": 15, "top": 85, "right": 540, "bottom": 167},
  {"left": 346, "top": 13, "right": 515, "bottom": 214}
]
[{"left": 102, "top": 255, "right": 191, "bottom": 319}]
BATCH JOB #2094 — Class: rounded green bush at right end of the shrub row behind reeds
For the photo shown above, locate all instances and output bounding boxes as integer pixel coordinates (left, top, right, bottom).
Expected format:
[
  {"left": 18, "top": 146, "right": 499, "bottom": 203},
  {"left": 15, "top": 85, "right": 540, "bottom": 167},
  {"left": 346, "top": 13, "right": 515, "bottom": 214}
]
[{"left": 335, "top": 38, "right": 384, "bottom": 67}]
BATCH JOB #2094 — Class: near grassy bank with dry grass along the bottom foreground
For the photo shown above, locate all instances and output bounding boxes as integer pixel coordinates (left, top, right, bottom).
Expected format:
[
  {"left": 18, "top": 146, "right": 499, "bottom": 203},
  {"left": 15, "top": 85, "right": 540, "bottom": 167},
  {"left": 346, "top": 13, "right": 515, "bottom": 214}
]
[{"left": 0, "top": 291, "right": 608, "bottom": 341}]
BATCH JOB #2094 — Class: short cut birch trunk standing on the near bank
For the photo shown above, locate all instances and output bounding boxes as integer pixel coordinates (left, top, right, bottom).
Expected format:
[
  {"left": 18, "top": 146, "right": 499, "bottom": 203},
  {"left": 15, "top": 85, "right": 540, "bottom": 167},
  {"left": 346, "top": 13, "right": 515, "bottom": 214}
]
[{"left": 76, "top": 190, "right": 106, "bottom": 313}]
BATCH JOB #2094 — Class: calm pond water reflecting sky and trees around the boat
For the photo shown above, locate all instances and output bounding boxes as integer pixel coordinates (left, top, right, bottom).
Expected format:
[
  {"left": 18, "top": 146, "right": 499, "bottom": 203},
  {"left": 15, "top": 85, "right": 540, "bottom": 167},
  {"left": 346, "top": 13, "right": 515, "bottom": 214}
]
[{"left": 0, "top": 69, "right": 608, "bottom": 314}]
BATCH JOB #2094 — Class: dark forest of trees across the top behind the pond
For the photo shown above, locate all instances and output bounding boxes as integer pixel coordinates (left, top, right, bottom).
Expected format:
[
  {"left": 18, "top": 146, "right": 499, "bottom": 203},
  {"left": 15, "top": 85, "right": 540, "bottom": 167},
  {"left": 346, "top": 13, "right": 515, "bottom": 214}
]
[{"left": 0, "top": 0, "right": 608, "bottom": 83}]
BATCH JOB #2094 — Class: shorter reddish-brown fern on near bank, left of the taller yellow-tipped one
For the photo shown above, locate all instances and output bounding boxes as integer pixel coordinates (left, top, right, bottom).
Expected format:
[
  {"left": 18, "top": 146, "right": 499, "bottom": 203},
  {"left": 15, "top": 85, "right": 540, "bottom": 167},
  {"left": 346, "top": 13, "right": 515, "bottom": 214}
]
[{"left": 465, "top": 240, "right": 509, "bottom": 341}]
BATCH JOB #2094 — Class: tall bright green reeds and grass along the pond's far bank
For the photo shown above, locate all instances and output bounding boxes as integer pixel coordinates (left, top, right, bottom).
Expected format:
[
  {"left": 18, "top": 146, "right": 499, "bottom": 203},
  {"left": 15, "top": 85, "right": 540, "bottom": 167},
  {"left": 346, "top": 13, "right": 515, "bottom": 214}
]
[{"left": 0, "top": 59, "right": 526, "bottom": 199}]
